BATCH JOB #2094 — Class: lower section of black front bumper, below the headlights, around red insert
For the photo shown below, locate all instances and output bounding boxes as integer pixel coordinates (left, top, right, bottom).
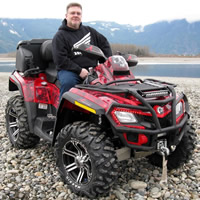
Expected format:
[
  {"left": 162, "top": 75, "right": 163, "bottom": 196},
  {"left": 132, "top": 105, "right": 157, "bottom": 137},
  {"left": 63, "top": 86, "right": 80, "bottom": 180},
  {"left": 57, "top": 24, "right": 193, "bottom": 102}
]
[{"left": 112, "top": 114, "right": 189, "bottom": 151}]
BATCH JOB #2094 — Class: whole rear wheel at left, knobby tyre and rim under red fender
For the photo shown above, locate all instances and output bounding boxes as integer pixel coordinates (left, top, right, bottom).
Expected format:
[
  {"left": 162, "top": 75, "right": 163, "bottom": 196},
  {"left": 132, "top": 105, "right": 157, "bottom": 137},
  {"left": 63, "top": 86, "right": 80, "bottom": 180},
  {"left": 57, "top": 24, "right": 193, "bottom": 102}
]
[{"left": 5, "top": 95, "right": 40, "bottom": 149}]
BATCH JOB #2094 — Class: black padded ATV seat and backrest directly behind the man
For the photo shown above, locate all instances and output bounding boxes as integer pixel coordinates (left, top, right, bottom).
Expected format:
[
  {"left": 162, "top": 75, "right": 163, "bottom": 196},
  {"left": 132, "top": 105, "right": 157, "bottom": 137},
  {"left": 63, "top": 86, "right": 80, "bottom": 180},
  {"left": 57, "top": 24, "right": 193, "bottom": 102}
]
[{"left": 40, "top": 40, "right": 57, "bottom": 83}]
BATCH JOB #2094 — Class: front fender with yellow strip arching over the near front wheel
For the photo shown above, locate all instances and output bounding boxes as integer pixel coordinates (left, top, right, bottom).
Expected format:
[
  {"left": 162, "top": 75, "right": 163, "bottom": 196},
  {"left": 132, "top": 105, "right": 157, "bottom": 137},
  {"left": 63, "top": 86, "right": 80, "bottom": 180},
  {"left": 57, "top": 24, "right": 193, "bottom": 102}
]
[{"left": 52, "top": 89, "right": 105, "bottom": 146}]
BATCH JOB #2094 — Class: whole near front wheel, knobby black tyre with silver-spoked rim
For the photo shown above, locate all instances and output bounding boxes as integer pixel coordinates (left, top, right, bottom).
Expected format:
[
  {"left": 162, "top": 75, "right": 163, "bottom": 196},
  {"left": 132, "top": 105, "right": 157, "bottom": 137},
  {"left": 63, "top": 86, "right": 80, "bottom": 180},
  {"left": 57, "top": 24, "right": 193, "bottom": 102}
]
[{"left": 55, "top": 122, "right": 118, "bottom": 198}]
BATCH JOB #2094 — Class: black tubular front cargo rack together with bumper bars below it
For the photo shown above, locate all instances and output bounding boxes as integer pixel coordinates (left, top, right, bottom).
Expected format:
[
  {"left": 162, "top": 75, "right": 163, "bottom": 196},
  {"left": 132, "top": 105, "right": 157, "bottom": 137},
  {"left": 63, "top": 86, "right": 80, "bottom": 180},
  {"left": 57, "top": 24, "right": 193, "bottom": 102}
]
[{"left": 76, "top": 79, "right": 189, "bottom": 150}]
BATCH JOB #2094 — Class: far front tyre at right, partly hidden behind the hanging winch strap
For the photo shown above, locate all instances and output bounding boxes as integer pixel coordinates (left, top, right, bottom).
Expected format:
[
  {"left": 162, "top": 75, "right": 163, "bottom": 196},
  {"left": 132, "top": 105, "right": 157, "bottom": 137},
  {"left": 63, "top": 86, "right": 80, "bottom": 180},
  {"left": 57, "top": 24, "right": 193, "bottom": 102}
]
[{"left": 148, "top": 123, "right": 196, "bottom": 170}]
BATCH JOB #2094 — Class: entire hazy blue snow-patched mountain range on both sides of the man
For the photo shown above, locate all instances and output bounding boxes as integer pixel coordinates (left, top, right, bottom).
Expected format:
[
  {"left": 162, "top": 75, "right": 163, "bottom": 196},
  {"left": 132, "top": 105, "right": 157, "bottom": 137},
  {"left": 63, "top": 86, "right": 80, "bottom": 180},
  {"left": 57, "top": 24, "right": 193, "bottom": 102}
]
[{"left": 0, "top": 18, "right": 200, "bottom": 55}]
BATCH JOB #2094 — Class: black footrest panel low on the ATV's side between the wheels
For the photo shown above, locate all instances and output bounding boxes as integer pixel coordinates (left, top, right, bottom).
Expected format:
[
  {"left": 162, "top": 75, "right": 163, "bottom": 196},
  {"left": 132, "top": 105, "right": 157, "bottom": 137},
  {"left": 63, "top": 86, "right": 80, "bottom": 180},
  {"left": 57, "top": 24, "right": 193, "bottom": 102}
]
[{"left": 34, "top": 117, "right": 55, "bottom": 142}]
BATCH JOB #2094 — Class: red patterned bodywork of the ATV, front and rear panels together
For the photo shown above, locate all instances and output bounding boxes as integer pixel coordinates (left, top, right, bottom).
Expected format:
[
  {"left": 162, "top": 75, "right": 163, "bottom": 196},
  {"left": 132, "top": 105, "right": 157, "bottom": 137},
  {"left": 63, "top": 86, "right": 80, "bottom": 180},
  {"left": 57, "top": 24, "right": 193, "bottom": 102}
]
[{"left": 11, "top": 51, "right": 185, "bottom": 146}]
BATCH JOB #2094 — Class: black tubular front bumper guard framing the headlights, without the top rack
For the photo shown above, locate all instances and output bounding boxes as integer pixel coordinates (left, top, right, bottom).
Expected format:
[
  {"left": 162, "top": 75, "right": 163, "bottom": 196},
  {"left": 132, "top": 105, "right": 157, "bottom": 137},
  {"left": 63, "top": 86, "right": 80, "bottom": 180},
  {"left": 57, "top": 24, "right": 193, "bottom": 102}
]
[{"left": 107, "top": 87, "right": 189, "bottom": 151}]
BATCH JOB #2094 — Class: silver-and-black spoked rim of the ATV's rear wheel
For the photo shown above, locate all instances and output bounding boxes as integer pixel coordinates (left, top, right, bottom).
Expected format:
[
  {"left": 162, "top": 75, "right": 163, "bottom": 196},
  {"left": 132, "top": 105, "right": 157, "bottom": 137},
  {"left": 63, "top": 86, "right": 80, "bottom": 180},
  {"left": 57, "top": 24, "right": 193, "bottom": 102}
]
[{"left": 8, "top": 108, "right": 19, "bottom": 141}]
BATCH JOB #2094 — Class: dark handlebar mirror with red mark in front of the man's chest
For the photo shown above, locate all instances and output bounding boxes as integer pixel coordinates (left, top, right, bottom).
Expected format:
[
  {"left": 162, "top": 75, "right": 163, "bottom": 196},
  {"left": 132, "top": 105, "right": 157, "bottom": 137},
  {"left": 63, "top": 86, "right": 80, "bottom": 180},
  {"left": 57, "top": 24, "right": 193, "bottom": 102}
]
[{"left": 72, "top": 44, "right": 107, "bottom": 62}]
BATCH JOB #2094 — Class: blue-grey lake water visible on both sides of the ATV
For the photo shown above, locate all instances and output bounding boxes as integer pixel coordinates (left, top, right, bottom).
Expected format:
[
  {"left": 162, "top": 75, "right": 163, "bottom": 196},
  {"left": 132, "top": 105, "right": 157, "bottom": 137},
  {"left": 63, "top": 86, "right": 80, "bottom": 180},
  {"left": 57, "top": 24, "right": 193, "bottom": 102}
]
[{"left": 0, "top": 62, "right": 200, "bottom": 78}]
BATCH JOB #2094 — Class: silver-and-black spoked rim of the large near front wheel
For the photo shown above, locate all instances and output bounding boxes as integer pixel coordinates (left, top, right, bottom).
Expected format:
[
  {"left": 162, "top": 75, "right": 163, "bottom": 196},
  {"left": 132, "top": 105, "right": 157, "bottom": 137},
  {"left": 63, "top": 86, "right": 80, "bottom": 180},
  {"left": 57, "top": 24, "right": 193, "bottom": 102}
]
[{"left": 62, "top": 139, "right": 92, "bottom": 185}]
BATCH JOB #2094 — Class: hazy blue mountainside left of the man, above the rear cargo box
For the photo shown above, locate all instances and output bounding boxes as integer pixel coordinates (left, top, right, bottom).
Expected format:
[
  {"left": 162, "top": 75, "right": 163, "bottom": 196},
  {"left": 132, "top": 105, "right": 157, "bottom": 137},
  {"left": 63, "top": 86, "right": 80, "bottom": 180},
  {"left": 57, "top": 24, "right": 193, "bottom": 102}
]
[{"left": 0, "top": 18, "right": 61, "bottom": 53}]
